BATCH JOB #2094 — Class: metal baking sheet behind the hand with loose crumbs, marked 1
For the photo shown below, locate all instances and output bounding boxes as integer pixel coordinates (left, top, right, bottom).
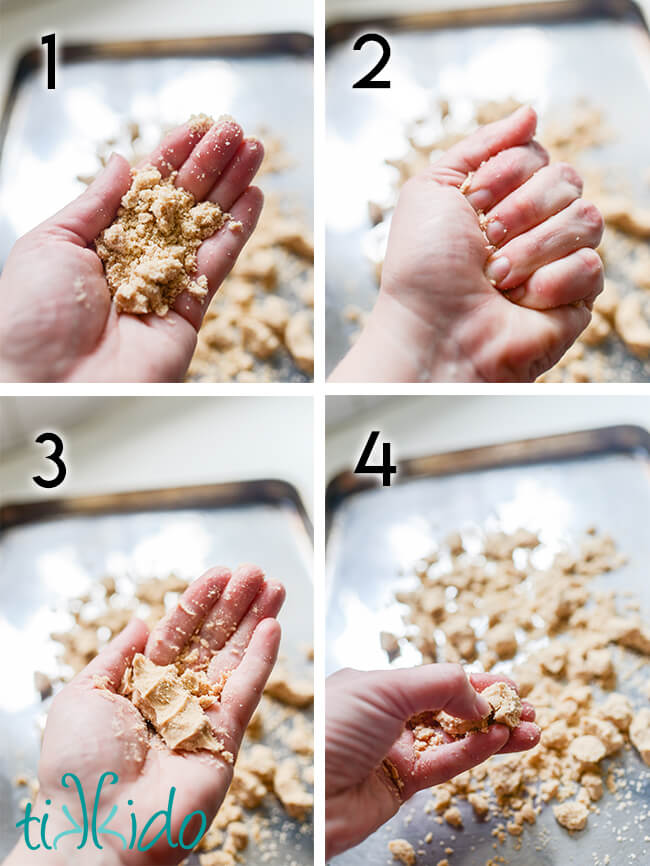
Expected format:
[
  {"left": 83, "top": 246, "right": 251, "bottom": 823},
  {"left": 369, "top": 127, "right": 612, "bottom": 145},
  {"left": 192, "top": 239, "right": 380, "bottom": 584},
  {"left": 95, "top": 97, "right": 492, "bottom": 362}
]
[{"left": 0, "top": 33, "right": 313, "bottom": 382}]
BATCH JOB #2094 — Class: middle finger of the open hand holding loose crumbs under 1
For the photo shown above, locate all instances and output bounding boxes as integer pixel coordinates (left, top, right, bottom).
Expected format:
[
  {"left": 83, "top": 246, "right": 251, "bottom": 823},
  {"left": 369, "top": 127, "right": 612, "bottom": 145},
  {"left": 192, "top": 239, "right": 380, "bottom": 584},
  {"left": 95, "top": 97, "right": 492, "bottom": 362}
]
[{"left": 176, "top": 119, "right": 244, "bottom": 201}]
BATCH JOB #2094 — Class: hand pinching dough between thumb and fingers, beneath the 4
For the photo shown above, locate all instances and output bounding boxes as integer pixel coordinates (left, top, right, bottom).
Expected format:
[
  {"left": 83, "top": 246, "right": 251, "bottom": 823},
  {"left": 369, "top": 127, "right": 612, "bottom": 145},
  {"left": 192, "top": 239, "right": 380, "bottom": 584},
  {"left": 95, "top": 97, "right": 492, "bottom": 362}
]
[{"left": 325, "top": 664, "right": 540, "bottom": 858}]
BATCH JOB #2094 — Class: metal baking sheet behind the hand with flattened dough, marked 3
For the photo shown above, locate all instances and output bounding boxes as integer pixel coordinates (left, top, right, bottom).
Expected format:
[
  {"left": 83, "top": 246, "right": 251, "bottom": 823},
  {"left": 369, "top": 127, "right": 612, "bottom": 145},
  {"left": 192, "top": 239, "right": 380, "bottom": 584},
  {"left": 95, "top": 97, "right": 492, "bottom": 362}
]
[{"left": 0, "top": 481, "right": 313, "bottom": 866}]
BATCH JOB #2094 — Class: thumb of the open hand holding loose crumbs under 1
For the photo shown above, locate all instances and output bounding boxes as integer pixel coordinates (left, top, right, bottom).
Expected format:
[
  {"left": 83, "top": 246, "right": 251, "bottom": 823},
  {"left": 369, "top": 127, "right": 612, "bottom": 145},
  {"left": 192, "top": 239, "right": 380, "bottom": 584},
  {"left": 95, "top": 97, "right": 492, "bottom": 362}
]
[{"left": 40, "top": 153, "right": 131, "bottom": 247}]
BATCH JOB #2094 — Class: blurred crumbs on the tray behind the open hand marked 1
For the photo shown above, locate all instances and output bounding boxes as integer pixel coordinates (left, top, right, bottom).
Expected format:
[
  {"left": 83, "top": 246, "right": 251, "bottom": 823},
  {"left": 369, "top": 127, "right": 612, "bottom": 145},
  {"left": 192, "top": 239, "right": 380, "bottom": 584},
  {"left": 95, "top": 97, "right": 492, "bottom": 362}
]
[{"left": 78, "top": 115, "right": 314, "bottom": 382}]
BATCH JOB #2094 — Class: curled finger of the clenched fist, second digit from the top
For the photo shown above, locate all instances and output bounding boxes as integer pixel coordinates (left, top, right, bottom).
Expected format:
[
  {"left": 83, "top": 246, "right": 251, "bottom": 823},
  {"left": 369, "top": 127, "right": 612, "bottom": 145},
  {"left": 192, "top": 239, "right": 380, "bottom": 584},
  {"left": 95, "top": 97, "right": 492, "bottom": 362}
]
[{"left": 465, "top": 141, "right": 549, "bottom": 214}]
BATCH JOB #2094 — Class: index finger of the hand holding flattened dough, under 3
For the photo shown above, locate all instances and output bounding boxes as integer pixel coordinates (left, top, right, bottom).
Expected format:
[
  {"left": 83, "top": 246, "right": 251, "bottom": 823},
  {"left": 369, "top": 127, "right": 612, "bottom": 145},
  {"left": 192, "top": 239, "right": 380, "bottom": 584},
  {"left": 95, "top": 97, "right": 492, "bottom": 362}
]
[{"left": 145, "top": 568, "right": 230, "bottom": 665}]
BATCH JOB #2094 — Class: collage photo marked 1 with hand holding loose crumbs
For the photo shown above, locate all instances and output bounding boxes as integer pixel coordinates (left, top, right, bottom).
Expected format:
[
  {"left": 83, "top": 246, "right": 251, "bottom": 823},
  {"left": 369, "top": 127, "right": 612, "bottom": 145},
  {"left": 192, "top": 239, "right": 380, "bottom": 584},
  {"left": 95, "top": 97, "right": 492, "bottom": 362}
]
[{"left": 0, "top": 0, "right": 314, "bottom": 383}]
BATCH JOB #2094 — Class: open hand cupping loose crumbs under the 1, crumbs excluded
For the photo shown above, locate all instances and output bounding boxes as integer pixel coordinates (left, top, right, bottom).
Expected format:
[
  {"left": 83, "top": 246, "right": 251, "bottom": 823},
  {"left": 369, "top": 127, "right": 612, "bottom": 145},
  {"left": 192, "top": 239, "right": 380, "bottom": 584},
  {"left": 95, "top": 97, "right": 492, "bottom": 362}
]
[{"left": 0, "top": 120, "right": 264, "bottom": 382}]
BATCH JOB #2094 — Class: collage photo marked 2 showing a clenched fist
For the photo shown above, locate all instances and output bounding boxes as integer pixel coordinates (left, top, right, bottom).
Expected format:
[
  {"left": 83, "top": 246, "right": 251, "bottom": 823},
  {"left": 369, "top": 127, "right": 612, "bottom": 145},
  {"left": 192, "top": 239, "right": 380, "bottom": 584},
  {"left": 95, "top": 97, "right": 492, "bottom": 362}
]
[{"left": 324, "top": 0, "right": 650, "bottom": 383}]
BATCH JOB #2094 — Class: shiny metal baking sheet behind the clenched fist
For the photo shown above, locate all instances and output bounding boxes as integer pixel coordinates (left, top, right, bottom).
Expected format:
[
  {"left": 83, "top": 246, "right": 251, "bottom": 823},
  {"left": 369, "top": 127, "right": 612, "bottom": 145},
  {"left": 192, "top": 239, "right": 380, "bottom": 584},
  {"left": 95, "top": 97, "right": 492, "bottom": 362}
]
[{"left": 325, "top": 0, "right": 650, "bottom": 381}]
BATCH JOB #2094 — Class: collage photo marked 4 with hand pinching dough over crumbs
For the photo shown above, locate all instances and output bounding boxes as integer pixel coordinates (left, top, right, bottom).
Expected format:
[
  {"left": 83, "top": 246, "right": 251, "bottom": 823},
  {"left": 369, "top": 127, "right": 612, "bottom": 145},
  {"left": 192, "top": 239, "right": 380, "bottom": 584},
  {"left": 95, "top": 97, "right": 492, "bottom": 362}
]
[{"left": 325, "top": 396, "right": 650, "bottom": 866}]
